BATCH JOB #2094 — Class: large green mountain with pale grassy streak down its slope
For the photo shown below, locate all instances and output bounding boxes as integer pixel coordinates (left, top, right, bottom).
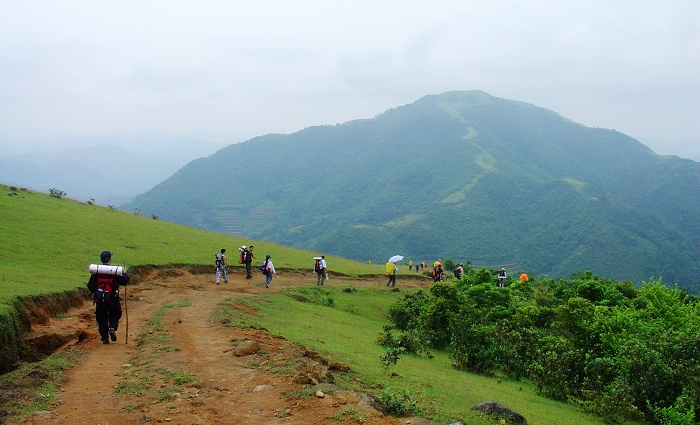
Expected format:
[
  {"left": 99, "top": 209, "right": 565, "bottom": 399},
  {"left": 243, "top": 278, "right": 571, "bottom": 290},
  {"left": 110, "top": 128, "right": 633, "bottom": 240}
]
[{"left": 127, "top": 91, "right": 700, "bottom": 291}]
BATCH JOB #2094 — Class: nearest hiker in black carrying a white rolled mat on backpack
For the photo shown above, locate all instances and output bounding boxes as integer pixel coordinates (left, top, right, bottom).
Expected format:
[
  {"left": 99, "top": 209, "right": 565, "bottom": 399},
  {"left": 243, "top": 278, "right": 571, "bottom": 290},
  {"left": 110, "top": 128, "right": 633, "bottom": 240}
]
[{"left": 87, "top": 251, "right": 129, "bottom": 344}]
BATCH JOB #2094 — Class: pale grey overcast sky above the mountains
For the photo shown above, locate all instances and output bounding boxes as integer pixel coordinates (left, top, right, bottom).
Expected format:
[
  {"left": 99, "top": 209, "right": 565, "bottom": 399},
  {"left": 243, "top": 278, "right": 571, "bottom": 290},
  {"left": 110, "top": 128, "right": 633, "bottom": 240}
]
[{"left": 0, "top": 0, "right": 700, "bottom": 161}]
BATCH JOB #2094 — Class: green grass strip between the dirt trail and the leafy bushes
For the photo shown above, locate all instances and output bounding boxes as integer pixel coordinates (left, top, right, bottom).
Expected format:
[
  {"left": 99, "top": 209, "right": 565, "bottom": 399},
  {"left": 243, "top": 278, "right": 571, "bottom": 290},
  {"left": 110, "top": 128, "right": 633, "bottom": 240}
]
[{"left": 223, "top": 286, "right": 616, "bottom": 425}]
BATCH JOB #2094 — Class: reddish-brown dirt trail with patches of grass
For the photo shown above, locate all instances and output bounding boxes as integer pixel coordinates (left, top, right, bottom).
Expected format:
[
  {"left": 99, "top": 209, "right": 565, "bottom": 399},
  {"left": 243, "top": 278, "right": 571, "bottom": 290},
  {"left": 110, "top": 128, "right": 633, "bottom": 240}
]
[{"left": 16, "top": 272, "right": 425, "bottom": 425}]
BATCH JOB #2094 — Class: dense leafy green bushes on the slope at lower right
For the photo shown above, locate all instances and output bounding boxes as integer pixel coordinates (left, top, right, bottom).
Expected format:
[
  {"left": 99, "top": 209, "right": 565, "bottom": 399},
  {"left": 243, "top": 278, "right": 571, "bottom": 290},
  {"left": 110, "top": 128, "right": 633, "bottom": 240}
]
[{"left": 379, "top": 269, "right": 700, "bottom": 424}]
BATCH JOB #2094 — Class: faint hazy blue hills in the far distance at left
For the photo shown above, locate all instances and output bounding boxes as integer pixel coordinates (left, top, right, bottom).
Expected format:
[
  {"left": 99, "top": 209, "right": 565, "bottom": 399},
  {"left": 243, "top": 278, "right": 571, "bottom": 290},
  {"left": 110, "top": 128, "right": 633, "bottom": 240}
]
[{"left": 0, "top": 135, "right": 216, "bottom": 206}]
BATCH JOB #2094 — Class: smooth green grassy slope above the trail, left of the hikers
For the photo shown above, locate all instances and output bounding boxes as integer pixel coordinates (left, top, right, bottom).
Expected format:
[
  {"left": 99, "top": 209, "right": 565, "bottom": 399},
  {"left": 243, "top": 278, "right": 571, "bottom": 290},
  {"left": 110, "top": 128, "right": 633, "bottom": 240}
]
[{"left": 0, "top": 185, "right": 383, "bottom": 314}]
